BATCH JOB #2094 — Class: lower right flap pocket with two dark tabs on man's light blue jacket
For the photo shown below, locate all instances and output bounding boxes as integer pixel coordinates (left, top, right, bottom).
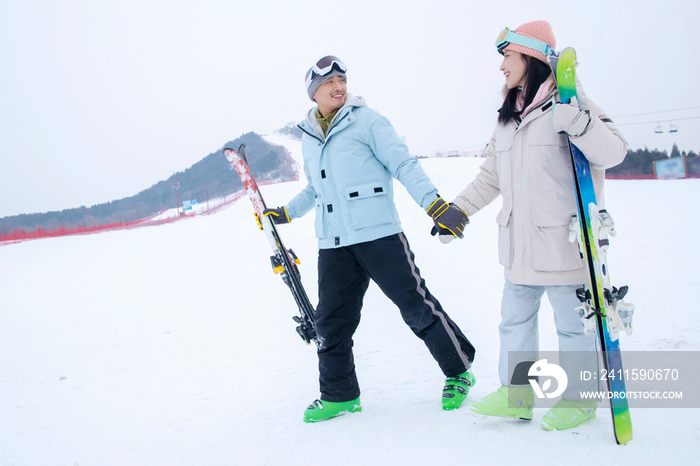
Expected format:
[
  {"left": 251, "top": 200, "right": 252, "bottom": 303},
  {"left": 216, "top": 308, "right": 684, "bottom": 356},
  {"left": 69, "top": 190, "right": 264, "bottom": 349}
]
[{"left": 345, "top": 182, "right": 395, "bottom": 230}]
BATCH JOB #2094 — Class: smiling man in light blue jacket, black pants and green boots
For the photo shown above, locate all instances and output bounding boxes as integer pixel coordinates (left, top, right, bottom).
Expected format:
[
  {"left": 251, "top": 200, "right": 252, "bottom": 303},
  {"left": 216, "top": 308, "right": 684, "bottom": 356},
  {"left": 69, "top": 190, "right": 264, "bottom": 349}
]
[{"left": 265, "top": 56, "right": 475, "bottom": 422}]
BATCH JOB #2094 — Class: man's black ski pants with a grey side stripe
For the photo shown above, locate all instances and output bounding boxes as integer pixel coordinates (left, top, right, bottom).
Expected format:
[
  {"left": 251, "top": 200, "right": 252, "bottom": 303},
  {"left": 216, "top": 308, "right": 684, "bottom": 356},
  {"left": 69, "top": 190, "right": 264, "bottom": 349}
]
[{"left": 316, "top": 233, "right": 475, "bottom": 402}]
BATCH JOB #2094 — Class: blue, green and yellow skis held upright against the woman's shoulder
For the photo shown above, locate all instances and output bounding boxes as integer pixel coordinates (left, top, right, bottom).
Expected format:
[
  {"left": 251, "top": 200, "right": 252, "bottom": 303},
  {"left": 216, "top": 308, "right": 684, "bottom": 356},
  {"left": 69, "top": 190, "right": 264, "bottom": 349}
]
[{"left": 548, "top": 48, "right": 634, "bottom": 444}]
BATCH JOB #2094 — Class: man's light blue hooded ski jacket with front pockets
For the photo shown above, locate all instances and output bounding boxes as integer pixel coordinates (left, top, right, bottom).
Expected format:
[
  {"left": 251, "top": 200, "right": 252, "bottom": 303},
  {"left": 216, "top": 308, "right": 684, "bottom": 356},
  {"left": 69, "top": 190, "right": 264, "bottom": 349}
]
[{"left": 286, "top": 94, "right": 438, "bottom": 249}]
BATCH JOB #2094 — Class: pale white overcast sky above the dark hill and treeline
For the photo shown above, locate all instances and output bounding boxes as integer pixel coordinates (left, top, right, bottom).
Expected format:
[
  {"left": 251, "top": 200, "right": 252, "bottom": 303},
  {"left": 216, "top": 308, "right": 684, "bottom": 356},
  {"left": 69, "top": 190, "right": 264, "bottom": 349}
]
[{"left": 0, "top": 0, "right": 700, "bottom": 217}]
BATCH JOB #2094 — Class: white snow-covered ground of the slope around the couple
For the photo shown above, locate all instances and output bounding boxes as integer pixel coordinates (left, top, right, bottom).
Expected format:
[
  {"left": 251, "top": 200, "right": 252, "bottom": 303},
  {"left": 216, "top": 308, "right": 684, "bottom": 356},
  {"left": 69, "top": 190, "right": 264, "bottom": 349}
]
[{"left": 0, "top": 133, "right": 700, "bottom": 466}]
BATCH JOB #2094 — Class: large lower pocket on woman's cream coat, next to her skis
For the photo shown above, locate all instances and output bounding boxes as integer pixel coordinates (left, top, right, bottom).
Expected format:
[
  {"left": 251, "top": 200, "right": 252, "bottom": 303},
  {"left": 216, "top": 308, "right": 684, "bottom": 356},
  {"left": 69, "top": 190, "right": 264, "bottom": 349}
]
[{"left": 531, "top": 219, "right": 583, "bottom": 272}]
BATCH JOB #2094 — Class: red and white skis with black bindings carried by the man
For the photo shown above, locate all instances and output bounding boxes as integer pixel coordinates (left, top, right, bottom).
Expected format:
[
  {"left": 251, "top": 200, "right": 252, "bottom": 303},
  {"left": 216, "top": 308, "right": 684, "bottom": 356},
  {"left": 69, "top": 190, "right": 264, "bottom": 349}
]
[{"left": 224, "top": 144, "right": 316, "bottom": 345}]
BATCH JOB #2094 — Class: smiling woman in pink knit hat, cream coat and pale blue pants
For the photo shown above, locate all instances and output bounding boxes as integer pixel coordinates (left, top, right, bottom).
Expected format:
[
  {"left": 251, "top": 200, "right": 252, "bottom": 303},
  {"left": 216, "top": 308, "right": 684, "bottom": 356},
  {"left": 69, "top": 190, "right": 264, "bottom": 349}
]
[{"left": 453, "top": 21, "right": 627, "bottom": 430}]
